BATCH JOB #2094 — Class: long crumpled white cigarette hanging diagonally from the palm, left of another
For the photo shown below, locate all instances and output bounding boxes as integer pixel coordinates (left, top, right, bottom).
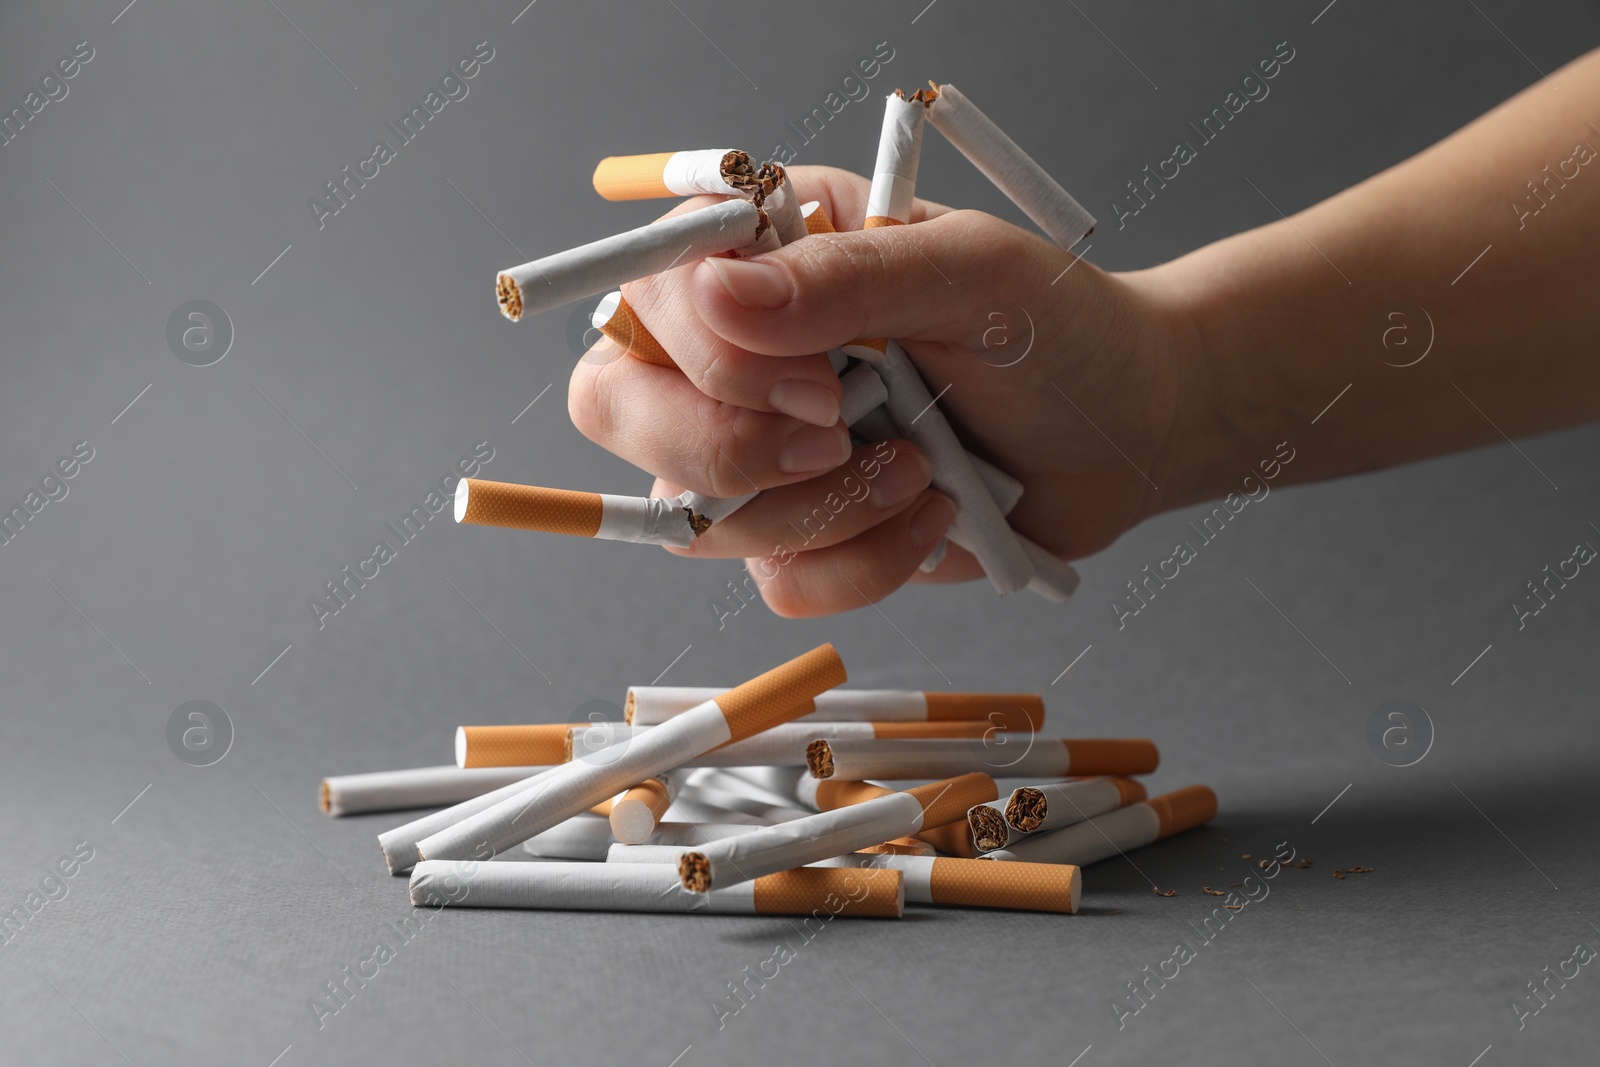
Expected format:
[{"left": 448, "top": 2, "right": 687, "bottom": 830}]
[{"left": 845, "top": 341, "right": 1034, "bottom": 593}]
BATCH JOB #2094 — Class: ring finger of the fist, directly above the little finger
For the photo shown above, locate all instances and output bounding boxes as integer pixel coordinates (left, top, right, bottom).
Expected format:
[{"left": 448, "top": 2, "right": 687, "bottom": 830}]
[{"left": 651, "top": 440, "right": 933, "bottom": 558}]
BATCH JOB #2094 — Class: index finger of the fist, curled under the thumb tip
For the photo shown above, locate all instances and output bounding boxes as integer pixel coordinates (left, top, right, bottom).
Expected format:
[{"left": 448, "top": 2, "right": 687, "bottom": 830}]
[{"left": 622, "top": 197, "right": 840, "bottom": 426}]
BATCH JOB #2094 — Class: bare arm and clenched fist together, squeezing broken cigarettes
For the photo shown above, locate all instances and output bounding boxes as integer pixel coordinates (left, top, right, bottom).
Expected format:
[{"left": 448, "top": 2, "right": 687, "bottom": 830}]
[{"left": 568, "top": 53, "right": 1600, "bottom": 616}]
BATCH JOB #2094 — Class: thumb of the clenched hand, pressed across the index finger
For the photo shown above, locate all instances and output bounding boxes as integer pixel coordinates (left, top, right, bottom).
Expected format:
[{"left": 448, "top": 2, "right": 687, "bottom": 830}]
[{"left": 690, "top": 211, "right": 1072, "bottom": 355}]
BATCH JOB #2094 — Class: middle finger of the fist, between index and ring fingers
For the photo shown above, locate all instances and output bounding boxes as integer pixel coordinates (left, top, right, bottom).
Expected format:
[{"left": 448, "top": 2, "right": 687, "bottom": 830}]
[{"left": 566, "top": 341, "right": 851, "bottom": 496}]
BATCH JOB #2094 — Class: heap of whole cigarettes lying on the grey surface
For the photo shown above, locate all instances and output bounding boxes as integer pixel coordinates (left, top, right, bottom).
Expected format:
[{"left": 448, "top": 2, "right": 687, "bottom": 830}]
[{"left": 331, "top": 645, "right": 1216, "bottom": 918}]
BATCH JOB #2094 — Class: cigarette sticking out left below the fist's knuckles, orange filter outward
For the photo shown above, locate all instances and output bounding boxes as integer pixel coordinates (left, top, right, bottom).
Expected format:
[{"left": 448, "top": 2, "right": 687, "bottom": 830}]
[{"left": 456, "top": 478, "right": 696, "bottom": 549}]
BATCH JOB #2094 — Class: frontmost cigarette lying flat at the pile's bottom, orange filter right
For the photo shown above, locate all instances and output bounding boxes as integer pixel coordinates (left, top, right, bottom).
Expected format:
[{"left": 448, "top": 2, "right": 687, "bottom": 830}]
[{"left": 411, "top": 861, "right": 906, "bottom": 918}]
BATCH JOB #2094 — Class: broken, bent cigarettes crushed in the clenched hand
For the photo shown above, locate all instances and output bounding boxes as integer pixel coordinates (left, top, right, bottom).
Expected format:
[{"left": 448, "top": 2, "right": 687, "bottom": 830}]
[{"left": 454, "top": 83, "right": 1094, "bottom": 601}]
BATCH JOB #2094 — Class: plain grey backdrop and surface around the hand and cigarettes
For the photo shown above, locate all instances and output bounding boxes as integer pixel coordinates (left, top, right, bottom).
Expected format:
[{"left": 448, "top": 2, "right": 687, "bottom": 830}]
[{"left": 0, "top": 0, "right": 1600, "bottom": 1067}]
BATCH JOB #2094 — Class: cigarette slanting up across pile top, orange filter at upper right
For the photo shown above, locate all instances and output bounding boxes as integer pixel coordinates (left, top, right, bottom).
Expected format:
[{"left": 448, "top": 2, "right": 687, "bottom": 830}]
[{"left": 418, "top": 645, "right": 857, "bottom": 859}]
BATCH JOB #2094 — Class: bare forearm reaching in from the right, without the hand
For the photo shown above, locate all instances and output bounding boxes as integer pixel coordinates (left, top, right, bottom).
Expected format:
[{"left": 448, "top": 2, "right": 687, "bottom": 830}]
[{"left": 1158, "top": 45, "right": 1600, "bottom": 506}]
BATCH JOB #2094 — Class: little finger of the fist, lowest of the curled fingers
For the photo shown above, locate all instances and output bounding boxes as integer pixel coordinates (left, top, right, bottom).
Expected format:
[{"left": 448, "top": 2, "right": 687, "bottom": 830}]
[{"left": 746, "top": 490, "right": 955, "bottom": 619}]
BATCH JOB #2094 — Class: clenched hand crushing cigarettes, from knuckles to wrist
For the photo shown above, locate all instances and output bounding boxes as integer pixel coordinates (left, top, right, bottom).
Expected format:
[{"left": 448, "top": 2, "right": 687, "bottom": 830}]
[{"left": 568, "top": 168, "right": 1224, "bottom": 616}]
